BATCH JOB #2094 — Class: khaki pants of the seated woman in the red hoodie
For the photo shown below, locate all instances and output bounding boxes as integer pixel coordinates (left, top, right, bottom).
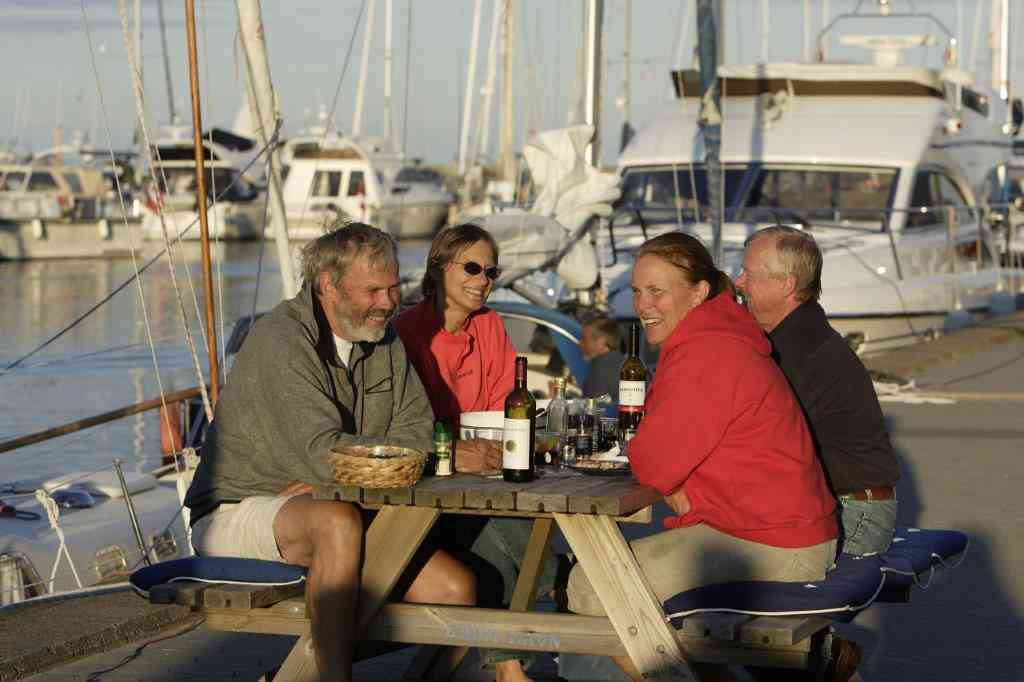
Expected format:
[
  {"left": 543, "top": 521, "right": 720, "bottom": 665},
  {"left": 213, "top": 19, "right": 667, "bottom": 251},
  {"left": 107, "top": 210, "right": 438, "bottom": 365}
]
[{"left": 568, "top": 523, "right": 836, "bottom": 615}]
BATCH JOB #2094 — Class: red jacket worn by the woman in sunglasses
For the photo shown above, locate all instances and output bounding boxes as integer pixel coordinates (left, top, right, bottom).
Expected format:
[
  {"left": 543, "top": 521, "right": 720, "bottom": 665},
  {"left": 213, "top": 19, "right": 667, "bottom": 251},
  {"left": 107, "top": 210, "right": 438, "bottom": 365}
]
[{"left": 394, "top": 296, "right": 515, "bottom": 425}]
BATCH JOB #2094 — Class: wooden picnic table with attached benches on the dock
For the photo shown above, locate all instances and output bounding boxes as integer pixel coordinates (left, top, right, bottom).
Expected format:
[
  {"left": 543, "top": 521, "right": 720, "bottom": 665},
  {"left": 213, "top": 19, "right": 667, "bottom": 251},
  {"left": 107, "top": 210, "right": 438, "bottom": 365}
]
[{"left": 134, "top": 472, "right": 958, "bottom": 680}]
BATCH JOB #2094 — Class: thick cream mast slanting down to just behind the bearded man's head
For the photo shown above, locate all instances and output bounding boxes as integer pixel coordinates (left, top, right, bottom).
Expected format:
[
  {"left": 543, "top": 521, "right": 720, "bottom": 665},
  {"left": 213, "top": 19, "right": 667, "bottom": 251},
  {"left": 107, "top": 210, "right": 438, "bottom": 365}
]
[{"left": 236, "top": 0, "right": 299, "bottom": 298}]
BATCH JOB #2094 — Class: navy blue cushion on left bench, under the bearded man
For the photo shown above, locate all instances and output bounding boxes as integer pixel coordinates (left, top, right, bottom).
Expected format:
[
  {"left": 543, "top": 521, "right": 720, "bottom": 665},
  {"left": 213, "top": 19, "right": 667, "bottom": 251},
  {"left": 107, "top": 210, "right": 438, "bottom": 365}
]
[{"left": 128, "top": 556, "right": 306, "bottom": 597}]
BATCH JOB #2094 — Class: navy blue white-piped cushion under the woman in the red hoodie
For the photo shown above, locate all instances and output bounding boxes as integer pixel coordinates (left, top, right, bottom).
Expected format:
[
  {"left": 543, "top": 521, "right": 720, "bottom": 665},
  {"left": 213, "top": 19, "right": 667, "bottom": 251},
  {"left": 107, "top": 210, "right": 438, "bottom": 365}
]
[{"left": 665, "top": 555, "right": 886, "bottom": 628}]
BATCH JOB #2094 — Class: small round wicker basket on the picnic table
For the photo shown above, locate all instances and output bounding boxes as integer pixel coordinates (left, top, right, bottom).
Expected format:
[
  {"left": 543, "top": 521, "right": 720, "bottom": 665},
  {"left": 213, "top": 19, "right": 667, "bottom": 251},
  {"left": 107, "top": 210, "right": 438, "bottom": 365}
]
[{"left": 327, "top": 445, "right": 427, "bottom": 487}]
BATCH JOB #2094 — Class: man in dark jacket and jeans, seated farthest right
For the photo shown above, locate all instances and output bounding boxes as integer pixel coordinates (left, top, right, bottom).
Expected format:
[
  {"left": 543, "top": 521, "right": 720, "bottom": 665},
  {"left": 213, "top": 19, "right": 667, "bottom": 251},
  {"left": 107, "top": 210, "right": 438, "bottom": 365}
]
[{"left": 736, "top": 225, "right": 899, "bottom": 555}]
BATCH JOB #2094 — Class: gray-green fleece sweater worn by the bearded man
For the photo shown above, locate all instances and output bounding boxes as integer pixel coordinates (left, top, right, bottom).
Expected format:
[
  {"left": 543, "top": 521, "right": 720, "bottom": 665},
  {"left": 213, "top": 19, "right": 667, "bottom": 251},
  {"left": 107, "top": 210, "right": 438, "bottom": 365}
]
[{"left": 185, "top": 285, "right": 433, "bottom": 519}]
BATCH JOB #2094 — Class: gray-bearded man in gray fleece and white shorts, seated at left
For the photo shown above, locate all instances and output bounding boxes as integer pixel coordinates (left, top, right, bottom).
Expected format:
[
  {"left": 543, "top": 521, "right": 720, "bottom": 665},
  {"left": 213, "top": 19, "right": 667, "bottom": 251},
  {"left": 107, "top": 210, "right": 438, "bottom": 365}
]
[{"left": 185, "top": 223, "right": 476, "bottom": 680}]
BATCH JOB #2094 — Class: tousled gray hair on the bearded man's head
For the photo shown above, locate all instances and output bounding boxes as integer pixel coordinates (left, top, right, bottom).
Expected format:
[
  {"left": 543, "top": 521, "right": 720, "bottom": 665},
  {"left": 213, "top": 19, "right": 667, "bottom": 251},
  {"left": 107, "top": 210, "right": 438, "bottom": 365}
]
[{"left": 302, "top": 222, "right": 398, "bottom": 294}]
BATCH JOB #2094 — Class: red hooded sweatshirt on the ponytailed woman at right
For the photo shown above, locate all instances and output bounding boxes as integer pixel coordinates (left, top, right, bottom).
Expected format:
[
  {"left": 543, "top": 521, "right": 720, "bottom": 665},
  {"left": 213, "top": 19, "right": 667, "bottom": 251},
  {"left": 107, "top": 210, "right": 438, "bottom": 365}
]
[{"left": 629, "top": 294, "right": 839, "bottom": 548}]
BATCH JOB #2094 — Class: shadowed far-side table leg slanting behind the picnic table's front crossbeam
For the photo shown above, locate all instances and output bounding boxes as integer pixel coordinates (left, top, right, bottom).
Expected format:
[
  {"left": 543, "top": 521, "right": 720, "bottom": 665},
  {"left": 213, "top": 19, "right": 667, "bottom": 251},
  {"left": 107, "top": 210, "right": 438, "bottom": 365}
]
[{"left": 406, "top": 518, "right": 554, "bottom": 680}]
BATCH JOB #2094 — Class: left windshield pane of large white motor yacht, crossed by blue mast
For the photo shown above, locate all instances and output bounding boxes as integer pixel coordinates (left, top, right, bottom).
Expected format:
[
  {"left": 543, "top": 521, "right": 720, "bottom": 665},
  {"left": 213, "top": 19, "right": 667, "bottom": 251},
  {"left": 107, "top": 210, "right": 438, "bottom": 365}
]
[{"left": 618, "top": 165, "right": 746, "bottom": 222}]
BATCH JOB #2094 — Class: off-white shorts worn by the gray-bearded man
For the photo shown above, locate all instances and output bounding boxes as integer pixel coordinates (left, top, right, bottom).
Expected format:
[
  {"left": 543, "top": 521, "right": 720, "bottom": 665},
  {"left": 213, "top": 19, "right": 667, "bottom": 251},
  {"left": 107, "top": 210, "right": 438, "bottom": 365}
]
[{"left": 193, "top": 495, "right": 295, "bottom": 561}]
